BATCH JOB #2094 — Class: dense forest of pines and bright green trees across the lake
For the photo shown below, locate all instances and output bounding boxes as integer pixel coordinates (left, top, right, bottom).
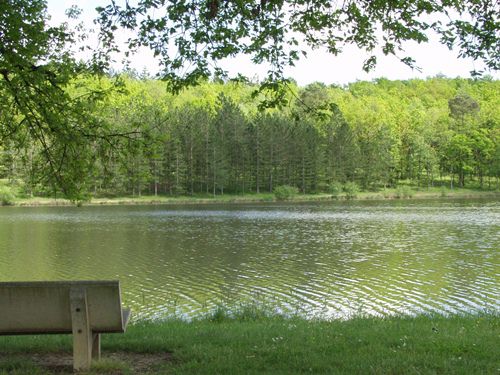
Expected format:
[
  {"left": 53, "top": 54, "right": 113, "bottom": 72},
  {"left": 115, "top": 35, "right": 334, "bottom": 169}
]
[{"left": 0, "top": 76, "right": 500, "bottom": 200}]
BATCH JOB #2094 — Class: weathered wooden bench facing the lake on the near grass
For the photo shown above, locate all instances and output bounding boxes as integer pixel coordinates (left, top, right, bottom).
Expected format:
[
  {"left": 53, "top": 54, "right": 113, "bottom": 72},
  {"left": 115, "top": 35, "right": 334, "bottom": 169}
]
[{"left": 0, "top": 281, "right": 130, "bottom": 370}]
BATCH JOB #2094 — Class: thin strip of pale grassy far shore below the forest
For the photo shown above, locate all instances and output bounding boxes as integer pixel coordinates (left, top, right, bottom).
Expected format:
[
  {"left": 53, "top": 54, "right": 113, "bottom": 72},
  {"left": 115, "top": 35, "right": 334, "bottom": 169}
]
[{"left": 4, "top": 188, "right": 500, "bottom": 207}]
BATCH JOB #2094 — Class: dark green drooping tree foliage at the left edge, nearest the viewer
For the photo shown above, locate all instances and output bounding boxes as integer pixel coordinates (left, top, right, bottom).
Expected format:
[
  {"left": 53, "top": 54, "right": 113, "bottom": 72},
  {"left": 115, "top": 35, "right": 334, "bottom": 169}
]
[{"left": 0, "top": 0, "right": 137, "bottom": 200}]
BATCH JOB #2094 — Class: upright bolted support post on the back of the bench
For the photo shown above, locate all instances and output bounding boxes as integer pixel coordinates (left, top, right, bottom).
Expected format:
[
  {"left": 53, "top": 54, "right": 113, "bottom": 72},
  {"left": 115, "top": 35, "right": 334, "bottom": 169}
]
[{"left": 70, "top": 288, "right": 93, "bottom": 371}]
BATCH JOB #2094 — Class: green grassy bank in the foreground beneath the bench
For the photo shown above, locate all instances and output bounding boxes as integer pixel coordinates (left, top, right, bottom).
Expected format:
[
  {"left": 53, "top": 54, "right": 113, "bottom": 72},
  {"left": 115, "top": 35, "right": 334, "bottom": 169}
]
[{"left": 0, "top": 314, "right": 500, "bottom": 374}]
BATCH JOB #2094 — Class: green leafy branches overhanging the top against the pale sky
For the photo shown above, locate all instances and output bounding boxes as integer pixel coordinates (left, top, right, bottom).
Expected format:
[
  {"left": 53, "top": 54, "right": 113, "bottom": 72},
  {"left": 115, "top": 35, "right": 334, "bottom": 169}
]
[{"left": 97, "top": 0, "right": 500, "bottom": 89}]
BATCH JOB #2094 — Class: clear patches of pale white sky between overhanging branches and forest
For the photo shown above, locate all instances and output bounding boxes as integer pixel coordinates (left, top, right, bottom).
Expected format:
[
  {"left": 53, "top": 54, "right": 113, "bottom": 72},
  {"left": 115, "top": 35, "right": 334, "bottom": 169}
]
[{"left": 47, "top": 0, "right": 500, "bottom": 86}]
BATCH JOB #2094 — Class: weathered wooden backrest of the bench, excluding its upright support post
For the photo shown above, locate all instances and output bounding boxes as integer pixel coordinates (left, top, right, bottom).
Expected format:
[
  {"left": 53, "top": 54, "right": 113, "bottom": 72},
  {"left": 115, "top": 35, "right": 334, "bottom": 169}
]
[{"left": 0, "top": 281, "right": 126, "bottom": 335}]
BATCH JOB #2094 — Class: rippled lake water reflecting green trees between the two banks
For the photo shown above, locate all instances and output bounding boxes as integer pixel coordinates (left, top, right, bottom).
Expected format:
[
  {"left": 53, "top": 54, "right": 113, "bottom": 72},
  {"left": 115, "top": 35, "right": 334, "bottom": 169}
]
[{"left": 0, "top": 200, "right": 500, "bottom": 319}]
